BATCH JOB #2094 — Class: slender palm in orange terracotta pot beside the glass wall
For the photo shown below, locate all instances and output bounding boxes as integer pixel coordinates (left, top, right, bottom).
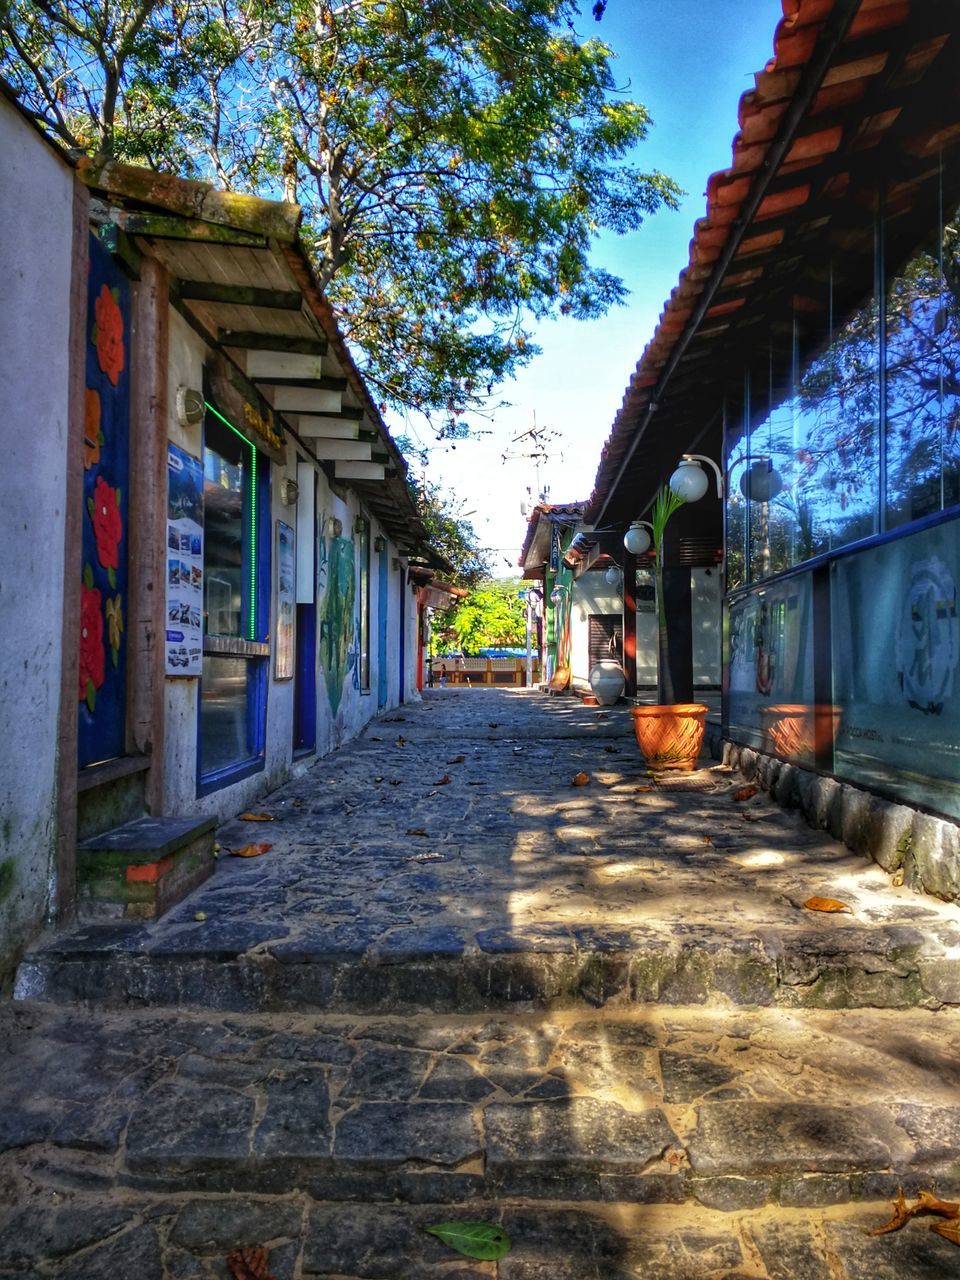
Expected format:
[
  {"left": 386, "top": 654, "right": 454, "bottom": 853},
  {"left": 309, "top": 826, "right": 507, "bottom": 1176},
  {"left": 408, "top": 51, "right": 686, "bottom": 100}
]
[{"left": 630, "top": 485, "right": 708, "bottom": 772}]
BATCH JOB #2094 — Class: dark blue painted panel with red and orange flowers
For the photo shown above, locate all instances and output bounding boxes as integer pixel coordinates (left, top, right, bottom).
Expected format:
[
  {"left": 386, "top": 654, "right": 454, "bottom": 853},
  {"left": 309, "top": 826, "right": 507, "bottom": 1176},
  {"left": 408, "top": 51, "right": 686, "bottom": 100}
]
[{"left": 78, "top": 236, "right": 131, "bottom": 767}]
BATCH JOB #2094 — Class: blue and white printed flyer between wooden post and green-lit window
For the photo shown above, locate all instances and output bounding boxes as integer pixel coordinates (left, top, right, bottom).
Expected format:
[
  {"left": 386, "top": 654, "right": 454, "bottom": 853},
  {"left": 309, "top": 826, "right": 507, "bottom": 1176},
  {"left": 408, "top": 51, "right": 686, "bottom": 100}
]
[{"left": 166, "top": 444, "right": 204, "bottom": 676}]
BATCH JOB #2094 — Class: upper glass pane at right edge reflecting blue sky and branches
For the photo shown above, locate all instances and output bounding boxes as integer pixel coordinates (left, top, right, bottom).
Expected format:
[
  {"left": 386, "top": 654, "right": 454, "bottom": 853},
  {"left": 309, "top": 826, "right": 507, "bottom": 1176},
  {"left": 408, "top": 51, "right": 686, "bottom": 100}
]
[{"left": 884, "top": 172, "right": 960, "bottom": 529}]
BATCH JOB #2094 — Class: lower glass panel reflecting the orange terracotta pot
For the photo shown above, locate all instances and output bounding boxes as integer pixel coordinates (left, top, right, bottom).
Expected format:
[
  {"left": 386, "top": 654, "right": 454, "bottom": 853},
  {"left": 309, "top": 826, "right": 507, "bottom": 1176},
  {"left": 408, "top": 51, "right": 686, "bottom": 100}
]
[{"left": 727, "top": 575, "right": 814, "bottom": 763}]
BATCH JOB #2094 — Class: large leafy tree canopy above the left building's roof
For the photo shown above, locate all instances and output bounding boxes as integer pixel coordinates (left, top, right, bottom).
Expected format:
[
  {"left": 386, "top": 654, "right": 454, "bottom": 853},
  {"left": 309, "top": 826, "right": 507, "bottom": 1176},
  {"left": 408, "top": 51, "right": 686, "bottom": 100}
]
[{"left": 0, "top": 0, "right": 678, "bottom": 435}]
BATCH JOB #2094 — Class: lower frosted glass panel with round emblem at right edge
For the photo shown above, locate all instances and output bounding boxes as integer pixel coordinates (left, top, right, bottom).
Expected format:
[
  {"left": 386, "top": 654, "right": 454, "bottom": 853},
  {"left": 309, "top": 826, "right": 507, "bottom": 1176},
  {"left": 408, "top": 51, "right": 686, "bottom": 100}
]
[{"left": 831, "top": 521, "right": 960, "bottom": 818}]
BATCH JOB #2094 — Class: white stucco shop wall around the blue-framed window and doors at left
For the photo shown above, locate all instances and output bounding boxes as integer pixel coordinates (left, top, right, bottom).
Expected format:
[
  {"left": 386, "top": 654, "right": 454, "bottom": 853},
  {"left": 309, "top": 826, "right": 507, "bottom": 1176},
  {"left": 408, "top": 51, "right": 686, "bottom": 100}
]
[{"left": 164, "top": 310, "right": 416, "bottom": 818}]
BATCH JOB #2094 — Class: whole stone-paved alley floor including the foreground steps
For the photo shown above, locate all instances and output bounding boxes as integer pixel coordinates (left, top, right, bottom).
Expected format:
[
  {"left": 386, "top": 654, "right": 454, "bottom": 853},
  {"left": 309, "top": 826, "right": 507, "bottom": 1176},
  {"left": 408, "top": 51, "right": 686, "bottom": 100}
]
[{"left": 0, "top": 690, "right": 960, "bottom": 1280}]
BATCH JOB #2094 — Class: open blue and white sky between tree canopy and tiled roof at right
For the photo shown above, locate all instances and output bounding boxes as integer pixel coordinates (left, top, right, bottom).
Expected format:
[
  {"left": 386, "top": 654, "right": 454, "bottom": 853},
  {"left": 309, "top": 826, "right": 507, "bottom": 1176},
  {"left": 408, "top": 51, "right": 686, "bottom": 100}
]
[{"left": 394, "top": 0, "right": 782, "bottom": 577}]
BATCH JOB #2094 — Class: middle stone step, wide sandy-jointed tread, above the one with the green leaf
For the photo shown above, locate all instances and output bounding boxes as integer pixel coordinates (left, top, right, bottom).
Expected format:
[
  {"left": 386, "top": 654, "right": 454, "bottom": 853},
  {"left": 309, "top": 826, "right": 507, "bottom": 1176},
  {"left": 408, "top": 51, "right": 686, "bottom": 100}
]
[{"left": 0, "top": 1005, "right": 960, "bottom": 1218}]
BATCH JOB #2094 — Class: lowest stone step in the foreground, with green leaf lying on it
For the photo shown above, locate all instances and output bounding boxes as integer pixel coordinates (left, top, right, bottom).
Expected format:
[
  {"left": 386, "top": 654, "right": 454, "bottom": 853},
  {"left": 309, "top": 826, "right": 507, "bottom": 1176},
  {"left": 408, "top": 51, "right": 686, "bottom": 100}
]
[{"left": 0, "top": 1188, "right": 960, "bottom": 1280}]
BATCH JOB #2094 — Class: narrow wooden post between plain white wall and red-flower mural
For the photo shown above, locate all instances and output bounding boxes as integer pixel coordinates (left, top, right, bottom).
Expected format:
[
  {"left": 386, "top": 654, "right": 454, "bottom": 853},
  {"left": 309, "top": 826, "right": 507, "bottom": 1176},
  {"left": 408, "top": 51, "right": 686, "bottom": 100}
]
[{"left": 51, "top": 182, "right": 90, "bottom": 924}]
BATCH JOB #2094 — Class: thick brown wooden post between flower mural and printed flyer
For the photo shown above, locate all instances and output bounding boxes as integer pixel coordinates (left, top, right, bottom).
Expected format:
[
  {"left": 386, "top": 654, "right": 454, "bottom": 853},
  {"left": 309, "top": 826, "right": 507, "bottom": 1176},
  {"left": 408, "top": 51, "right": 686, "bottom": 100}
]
[{"left": 127, "top": 257, "right": 169, "bottom": 814}]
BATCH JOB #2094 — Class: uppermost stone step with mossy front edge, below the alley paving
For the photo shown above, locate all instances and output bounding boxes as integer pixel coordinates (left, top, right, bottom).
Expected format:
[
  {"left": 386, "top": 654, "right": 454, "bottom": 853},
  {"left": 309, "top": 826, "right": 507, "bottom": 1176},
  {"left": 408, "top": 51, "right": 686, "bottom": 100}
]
[{"left": 15, "top": 916, "right": 960, "bottom": 1015}]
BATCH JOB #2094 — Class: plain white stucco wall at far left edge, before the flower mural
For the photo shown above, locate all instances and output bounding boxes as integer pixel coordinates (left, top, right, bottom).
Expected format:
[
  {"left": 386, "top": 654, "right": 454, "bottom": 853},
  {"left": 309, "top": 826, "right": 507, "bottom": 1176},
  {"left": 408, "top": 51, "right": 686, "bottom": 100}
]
[{"left": 0, "top": 97, "right": 73, "bottom": 973}]
